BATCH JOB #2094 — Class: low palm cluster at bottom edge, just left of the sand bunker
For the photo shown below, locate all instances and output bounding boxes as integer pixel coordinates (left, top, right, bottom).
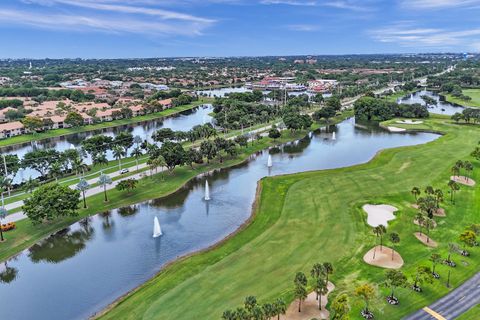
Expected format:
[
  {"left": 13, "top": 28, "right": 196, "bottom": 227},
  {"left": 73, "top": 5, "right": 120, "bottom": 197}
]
[{"left": 222, "top": 296, "right": 287, "bottom": 320}]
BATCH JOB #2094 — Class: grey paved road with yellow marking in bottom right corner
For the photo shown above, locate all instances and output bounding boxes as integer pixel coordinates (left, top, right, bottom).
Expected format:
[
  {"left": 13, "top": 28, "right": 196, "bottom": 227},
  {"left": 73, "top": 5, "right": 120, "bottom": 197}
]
[{"left": 403, "top": 272, "right": 480, "bottom": 320}]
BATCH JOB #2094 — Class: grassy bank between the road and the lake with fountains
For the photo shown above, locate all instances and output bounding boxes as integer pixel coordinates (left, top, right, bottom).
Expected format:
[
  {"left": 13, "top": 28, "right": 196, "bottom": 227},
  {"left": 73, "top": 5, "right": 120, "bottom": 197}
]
[{"left": 0, "top": 111, "right": 352, "bottom": 261}]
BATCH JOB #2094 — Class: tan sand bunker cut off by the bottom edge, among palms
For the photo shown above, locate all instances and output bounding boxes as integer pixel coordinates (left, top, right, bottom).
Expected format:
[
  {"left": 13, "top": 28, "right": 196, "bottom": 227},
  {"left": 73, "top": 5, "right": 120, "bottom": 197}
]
[{"left": 282, "top": 282, "right": 335, "bottom": 320}]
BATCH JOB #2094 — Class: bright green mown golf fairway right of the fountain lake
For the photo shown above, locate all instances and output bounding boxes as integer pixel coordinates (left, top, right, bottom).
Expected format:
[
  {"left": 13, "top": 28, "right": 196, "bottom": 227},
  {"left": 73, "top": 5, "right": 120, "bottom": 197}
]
[{"left": 96, "top": 118, "right": 480, "bottom": 319}]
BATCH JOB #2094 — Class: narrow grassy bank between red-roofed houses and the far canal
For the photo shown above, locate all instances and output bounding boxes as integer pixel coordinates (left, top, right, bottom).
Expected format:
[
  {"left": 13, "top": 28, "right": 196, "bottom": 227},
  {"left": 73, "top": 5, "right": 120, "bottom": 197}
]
[{"left": 0, "top": 98, "right": 211, "bottom": 147}]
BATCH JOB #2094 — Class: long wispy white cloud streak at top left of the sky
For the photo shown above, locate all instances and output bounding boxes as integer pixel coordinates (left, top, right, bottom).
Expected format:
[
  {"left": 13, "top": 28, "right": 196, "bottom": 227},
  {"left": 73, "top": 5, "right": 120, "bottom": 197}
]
[{"left": 8, "top": 0, "right": 216, "bottom": 35}]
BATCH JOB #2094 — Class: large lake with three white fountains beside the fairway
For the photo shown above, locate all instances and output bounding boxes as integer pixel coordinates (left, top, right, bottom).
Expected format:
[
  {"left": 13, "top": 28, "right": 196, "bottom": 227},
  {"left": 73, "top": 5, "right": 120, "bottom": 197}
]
[{"left": 0, "top": 119, "right": 438, "bottom": 320}]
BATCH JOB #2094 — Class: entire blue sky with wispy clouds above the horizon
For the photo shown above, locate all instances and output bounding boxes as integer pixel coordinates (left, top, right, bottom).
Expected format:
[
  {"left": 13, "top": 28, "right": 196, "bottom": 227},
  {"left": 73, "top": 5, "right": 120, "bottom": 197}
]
[{"left": 0, "top": 0, "right": 480, "bottom": 58}]
